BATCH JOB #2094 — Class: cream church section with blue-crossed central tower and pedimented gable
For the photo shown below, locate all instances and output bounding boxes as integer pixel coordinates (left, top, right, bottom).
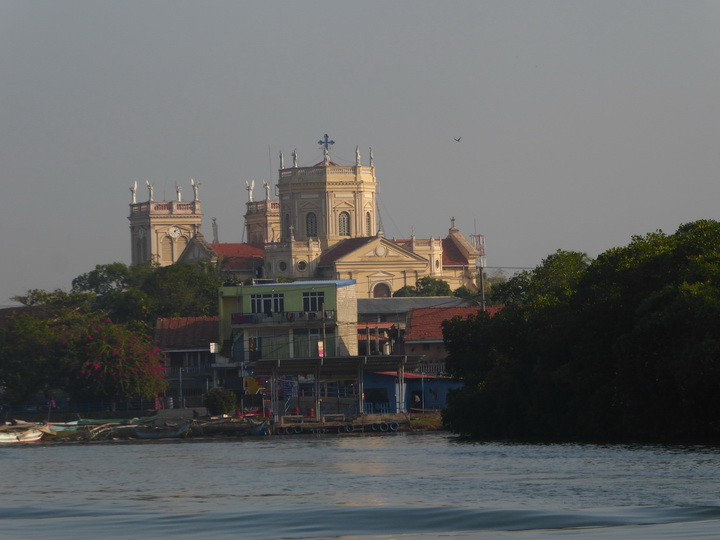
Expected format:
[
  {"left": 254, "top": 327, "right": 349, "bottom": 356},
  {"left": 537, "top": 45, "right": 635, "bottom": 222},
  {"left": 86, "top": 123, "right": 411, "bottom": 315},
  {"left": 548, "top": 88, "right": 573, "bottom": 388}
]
[{"left": 245, "top": 135, "right": 485, "bottom": 298}]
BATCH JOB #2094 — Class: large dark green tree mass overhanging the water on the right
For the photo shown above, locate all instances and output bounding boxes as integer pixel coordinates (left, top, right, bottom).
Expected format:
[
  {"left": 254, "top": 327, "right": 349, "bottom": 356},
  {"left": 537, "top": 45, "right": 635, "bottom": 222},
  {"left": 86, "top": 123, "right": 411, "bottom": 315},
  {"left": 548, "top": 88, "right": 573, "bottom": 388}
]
[{"left": 444, "top": 224, "right": 720, "bottom": 442}]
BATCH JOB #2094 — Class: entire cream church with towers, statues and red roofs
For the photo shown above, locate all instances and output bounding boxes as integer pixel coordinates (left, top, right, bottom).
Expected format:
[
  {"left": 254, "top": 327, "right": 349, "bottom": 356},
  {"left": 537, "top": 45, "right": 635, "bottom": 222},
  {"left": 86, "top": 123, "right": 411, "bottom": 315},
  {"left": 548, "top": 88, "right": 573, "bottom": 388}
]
[{"left": 128, "top": 135, "right": 485, "bottom": 298}]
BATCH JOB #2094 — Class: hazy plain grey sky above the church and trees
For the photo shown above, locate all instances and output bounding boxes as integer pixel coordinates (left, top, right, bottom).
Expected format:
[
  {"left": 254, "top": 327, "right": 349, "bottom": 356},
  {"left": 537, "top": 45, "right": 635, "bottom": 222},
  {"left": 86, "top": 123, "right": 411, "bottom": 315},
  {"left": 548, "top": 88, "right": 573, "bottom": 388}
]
[{"left": 0, "top": 0, "right": 720, "bottom": 306}]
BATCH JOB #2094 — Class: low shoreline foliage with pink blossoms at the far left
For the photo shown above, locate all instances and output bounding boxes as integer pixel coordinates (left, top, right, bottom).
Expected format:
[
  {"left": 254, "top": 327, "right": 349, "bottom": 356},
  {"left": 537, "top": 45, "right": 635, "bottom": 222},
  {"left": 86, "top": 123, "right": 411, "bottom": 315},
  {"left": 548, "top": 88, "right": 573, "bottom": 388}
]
[{"left": 0, "top": 291, "right": 165, "bottom": 404}]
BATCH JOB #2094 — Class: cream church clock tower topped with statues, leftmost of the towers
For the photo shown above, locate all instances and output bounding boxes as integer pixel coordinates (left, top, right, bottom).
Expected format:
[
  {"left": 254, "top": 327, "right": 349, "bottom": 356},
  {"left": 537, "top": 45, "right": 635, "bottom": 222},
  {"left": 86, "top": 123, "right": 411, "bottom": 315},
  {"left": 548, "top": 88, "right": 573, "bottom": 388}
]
[{"left": 128, "top": 180, "right": 203, "bottom": 266}]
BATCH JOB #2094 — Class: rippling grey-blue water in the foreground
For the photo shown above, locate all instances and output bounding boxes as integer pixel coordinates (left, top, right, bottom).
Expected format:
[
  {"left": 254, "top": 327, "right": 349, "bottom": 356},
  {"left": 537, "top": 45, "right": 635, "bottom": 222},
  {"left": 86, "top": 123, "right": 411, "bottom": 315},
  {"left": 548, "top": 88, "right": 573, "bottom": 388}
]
[{"left": 0, "top": 433, "right": 720, "bottom": 540}]
